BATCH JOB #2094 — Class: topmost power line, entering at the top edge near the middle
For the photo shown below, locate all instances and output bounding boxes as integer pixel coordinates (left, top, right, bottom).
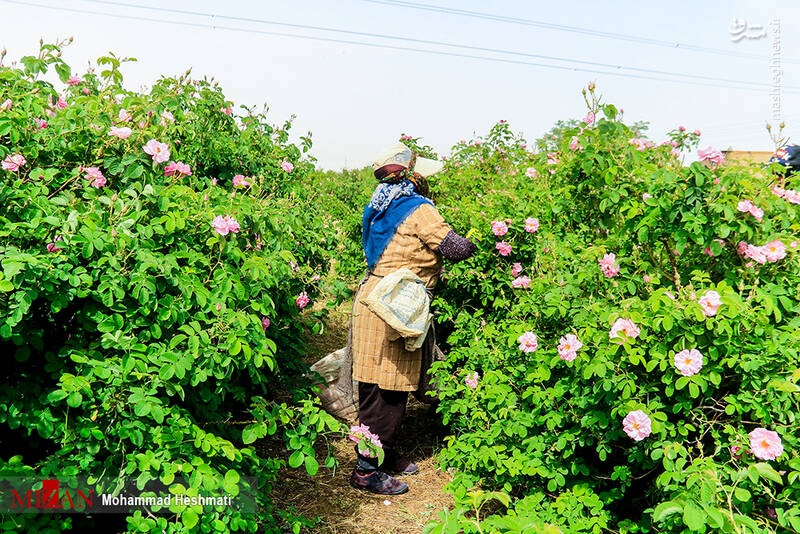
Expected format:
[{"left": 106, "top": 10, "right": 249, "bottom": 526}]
[{"left": 362, "top": 0, "right": 800, "bottom": 63}]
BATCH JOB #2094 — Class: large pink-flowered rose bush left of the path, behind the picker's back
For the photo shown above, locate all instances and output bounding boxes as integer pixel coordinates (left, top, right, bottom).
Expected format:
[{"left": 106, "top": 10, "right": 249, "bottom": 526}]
[{"left": 0, "top": 45, "right": 348, "bottom": 532}]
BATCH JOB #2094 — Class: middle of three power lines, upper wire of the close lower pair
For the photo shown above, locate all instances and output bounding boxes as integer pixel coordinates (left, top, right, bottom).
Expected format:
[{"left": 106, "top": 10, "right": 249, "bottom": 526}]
[{"left": 73, "top": 0, "right": 800, "bottom": 89}]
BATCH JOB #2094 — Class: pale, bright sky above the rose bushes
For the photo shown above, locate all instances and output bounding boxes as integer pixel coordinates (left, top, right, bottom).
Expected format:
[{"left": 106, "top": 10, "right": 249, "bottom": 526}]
[{"left": 0, "top": 0, "right": 800, "bottom": 169}]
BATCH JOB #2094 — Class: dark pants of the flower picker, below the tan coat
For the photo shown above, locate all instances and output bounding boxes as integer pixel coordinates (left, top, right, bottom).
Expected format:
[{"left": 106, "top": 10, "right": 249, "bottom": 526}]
[{"left": 358, "top": 382, "right": 408, "bottom": 469}]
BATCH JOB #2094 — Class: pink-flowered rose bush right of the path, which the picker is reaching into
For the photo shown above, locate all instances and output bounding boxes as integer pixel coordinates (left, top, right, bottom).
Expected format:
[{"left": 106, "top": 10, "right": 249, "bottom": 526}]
[{"left": 418, "top": 88, "right": 800, "bottom": 532}]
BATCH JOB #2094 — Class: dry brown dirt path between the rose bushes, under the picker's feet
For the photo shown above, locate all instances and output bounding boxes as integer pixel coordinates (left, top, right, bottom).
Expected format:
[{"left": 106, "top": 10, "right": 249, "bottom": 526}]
[{"left": 272, "top": 305, "right": 453, "bottom": 534}]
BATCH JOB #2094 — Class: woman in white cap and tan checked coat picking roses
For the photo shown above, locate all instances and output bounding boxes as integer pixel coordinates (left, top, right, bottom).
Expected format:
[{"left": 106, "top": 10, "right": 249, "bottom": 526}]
[{"left": 351, "top": 144, "right": 476, "bottom": 494}]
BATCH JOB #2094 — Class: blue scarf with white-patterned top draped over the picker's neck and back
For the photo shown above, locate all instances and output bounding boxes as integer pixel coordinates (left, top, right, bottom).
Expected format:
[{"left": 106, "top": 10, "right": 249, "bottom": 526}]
[{"left": 361, "top": 180, "right": 433, "bottom": 270}]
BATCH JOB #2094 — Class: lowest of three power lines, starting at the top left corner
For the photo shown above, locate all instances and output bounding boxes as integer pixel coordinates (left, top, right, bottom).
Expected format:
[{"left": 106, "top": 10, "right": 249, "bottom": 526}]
[{"left": 0, "top": 0, "right": 800, "bottom": 93}]
